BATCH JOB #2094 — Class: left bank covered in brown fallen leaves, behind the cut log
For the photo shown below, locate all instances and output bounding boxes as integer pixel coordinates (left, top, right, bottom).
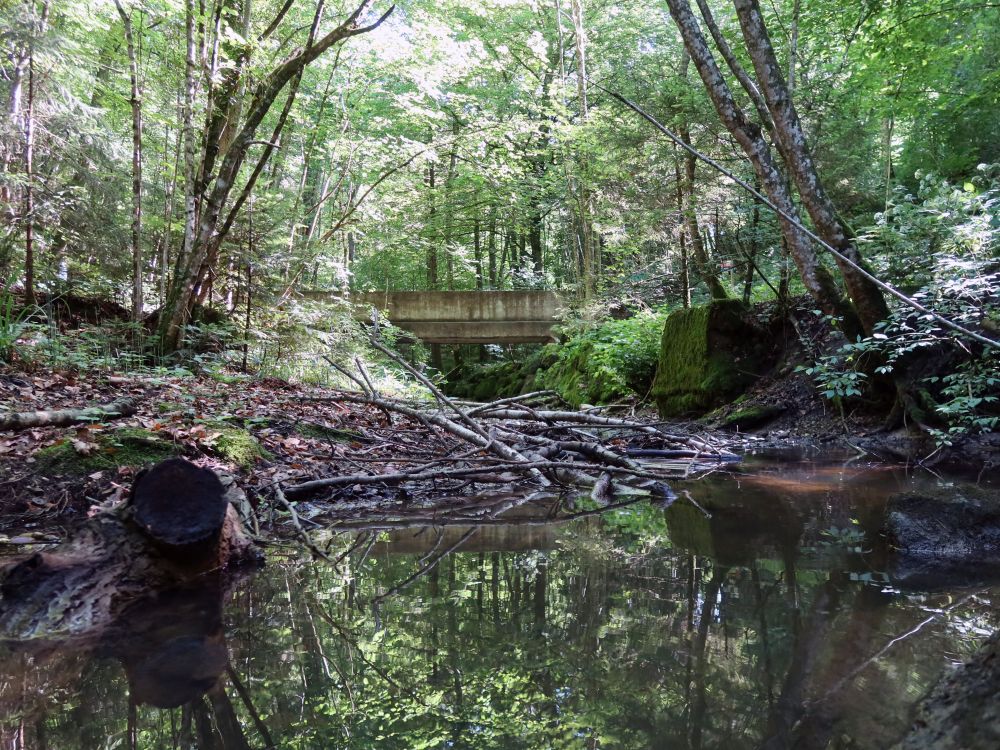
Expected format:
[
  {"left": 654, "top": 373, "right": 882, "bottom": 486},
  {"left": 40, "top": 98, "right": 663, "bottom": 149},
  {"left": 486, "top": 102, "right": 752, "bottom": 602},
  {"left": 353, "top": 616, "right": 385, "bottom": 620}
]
[{"left": 0, "top": 372, "right": 454, "bottom": 537}]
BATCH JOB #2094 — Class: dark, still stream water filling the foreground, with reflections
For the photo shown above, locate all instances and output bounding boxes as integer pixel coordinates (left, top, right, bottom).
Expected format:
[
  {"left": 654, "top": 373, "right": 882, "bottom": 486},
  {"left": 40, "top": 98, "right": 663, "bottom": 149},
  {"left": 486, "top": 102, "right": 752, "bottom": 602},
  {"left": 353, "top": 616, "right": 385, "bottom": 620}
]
[{"left": 0, "top": 458, "right": 1000, "bottom": 750}]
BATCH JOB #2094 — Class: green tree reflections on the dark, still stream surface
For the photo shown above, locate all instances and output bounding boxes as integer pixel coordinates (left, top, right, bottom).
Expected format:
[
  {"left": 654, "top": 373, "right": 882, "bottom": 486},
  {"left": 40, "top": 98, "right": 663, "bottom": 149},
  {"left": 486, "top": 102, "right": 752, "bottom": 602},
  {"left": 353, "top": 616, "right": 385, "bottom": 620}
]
[{"left": 0, "top": 505, "right": 996, "bottom": 750}]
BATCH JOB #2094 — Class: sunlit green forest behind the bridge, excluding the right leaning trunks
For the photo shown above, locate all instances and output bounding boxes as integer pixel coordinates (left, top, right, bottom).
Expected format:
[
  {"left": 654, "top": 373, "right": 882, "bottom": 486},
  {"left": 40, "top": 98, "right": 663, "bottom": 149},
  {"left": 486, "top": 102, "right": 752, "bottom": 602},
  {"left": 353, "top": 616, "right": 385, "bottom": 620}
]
[{"left": 0, "top": 0, "right": 1000, "bottom": 434}]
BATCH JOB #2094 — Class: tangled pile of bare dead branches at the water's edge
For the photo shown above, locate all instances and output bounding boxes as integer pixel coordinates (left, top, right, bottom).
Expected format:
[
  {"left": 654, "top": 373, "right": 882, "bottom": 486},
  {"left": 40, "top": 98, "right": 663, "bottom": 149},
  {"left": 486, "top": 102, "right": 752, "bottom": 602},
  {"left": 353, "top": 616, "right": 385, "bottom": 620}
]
[{"left": 277, "top": 332, "right": 736, "bottom": 536}]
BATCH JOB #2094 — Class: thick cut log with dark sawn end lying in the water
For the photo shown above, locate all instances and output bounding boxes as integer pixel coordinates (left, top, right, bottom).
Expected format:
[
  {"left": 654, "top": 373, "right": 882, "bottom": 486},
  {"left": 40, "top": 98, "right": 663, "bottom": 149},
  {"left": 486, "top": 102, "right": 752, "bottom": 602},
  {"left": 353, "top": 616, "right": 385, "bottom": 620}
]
[{"left": 0, "top": 459, "right": 261, "bottom": 640}]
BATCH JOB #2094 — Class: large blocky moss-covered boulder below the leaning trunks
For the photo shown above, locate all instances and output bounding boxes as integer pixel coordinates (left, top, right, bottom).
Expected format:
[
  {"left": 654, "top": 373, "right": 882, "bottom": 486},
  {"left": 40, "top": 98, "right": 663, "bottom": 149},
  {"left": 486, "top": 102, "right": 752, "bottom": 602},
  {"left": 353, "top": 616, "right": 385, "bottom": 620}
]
[{"left": 652, "top": 300, "right": 770, "bottom": 418}]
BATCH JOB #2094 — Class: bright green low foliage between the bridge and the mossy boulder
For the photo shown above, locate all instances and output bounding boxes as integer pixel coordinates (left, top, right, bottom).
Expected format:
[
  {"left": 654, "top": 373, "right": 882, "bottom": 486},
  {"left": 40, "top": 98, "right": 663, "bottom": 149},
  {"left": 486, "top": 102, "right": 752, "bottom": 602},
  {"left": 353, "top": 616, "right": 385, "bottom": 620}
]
[{"left": 537, "top": 313, "right": 665, "bottom": 406}]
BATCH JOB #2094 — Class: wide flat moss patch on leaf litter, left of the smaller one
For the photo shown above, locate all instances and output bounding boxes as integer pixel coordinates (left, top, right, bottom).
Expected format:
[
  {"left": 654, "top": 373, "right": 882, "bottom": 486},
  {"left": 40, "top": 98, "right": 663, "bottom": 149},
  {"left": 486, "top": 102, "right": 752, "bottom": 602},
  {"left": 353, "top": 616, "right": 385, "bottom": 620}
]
[{"left": 35, "top": 427, "right": 180, "bottom": 474}]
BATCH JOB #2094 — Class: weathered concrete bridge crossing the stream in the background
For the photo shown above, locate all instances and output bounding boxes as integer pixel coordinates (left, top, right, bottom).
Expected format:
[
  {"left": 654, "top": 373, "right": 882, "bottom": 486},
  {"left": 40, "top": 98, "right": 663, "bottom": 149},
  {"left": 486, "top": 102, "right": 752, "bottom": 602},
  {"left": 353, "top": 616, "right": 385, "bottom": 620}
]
[{"left": 309, "top": 290, "right": 562, "bottom": 344}]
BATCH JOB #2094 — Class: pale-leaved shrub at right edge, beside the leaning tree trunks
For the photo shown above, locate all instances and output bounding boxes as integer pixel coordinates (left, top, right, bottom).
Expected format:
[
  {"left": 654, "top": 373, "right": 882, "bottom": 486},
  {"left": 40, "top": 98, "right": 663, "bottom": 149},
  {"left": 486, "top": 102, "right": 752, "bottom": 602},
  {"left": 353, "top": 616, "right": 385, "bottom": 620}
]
[{"left": 803, "top": 165, "right": 1000, "bottom": 445}]
